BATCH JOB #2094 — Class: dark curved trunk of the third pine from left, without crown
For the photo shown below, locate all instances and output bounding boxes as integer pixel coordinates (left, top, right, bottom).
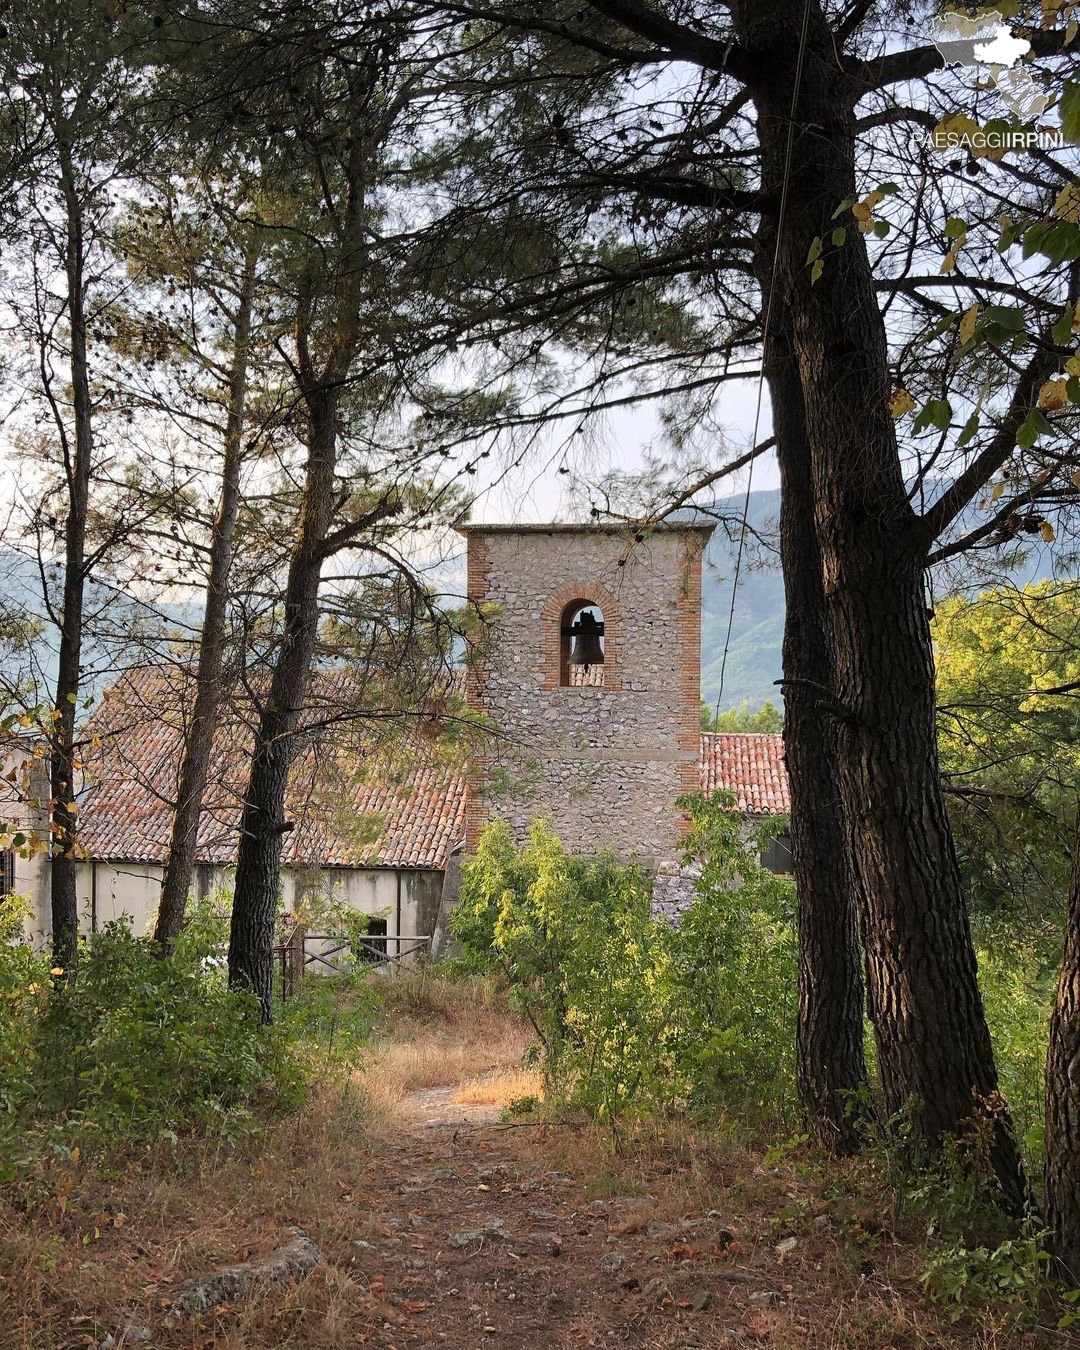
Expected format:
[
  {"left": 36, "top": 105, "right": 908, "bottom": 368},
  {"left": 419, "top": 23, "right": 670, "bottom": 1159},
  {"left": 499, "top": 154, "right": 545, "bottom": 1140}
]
[{"left": 228, "top": 387, "right": 338, "bottom": 1022}]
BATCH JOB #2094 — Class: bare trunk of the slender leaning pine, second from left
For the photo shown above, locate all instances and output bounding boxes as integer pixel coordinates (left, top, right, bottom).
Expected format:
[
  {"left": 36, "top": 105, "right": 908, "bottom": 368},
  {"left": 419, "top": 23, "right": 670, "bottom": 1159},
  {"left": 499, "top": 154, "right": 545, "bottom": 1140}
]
[{"left": 154, "top": 240, "right": 257, "bottom": 952}]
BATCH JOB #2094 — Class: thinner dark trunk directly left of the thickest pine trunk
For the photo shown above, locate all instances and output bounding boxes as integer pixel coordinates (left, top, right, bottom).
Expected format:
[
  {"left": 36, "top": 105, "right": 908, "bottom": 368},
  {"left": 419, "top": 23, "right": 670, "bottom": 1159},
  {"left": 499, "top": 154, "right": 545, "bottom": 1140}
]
[{"left": 767, "top": 303, "right": 867, "bottom": 1154}]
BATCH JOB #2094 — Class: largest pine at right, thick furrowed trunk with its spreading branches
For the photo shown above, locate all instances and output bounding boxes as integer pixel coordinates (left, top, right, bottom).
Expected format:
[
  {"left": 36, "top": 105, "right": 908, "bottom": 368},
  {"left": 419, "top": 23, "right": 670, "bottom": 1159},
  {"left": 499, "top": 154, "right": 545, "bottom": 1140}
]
[{"left": 410, "top": 0, "right": 1080, "bottom": 1206}]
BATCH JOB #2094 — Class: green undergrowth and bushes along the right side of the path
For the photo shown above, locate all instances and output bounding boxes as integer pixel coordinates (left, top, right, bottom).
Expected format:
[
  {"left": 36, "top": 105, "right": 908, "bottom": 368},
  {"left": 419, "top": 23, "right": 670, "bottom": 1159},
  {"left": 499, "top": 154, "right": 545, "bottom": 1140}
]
[{"left": 454, "top": 794, "right": 1072, "bottom": 1327}]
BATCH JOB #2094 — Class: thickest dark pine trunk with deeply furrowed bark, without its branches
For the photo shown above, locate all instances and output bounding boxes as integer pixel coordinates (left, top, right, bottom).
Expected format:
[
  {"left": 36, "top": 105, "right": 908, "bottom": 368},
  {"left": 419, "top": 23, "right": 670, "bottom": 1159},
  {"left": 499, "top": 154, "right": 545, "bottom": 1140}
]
[{"left": 733, "top": 0, "right": 1026, "bottom": 1211}]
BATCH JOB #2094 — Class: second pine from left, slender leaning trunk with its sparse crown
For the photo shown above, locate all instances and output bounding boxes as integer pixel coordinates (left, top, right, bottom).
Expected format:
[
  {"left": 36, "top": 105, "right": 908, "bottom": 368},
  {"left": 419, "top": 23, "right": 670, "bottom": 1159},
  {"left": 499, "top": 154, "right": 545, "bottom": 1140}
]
[{"left": 108, "top": 184, "right": 270, "bottom": 952}]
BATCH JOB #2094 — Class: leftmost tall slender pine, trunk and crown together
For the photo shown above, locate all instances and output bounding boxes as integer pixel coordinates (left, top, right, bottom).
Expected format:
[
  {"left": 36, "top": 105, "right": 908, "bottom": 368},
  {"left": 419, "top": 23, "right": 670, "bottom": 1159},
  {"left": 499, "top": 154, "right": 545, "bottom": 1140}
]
[{"left": 3, "top": 3, "right": 149, "bottom": 972}]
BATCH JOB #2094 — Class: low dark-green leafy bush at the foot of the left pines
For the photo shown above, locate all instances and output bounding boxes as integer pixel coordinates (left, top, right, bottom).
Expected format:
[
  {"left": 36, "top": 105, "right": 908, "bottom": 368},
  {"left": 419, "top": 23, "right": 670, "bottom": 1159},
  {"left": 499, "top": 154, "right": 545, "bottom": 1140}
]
[{"left": 0, "top": 910, "right": 305, "bottom": 1179}]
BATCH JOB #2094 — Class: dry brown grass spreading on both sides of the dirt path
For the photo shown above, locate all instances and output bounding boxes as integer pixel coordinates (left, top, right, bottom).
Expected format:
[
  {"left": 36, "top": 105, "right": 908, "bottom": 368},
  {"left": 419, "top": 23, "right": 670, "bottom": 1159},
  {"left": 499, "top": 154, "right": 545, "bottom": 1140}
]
[{"left": 0, "top": 975, "right": 1069, "bottom": 1350}]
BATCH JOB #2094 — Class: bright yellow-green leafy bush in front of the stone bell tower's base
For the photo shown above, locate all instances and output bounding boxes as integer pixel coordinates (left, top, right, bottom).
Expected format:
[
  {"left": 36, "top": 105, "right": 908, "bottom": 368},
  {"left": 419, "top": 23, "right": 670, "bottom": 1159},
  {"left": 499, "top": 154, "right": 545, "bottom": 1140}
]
[{"left": 452, "top": 794, "right": 795, "bottom": 1127}]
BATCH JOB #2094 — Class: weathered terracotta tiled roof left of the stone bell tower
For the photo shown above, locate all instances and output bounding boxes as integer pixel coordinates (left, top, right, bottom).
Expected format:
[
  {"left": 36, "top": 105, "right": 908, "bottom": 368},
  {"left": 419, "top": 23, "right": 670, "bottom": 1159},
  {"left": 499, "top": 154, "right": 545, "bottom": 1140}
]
[{"left": 80, "top": 667, "right": 464, "bottom": 869}]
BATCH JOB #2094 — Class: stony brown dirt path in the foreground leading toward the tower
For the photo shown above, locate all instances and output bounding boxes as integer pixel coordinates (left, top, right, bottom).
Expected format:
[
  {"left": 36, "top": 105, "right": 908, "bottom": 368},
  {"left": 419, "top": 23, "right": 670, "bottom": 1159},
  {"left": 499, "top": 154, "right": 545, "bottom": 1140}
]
[{"left": 355, "top": 1088, "right": 805, "bottom": 1350}]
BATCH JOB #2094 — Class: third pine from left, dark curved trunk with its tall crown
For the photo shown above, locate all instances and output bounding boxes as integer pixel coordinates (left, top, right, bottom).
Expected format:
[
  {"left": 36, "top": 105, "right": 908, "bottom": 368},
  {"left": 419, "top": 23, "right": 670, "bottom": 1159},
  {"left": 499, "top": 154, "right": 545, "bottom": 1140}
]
[{"left": 163, "top": 3, "right": 472, "bottom": 1019}]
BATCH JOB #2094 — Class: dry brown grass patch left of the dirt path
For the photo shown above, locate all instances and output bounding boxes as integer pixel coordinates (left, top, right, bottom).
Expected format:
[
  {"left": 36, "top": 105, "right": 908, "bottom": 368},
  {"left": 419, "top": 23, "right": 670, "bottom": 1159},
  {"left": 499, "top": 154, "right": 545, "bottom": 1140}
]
[{"left": 0, "top": 1079, "right": 377, "bottom": 1350}]
